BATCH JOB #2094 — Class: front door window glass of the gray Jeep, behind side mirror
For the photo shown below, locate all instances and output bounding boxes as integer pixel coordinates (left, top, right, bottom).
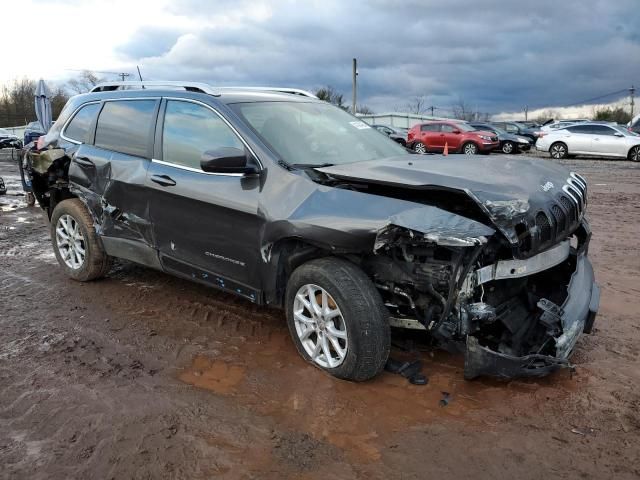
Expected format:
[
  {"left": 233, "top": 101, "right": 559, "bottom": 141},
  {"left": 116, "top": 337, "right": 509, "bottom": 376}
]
[{"left": 162, "top": 100, "right": 244, "bottom": 170}]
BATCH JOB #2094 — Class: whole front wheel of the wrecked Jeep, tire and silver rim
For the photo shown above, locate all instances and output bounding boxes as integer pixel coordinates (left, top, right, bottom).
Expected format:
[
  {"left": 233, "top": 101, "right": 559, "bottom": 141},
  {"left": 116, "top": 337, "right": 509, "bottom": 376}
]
[{"left": 285, "top": 258, "right": 391, "bottom": 382}]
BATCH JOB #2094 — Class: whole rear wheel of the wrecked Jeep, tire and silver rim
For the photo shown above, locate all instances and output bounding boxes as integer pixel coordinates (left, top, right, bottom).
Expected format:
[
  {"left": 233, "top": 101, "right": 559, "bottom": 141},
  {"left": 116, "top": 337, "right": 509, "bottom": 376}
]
[{"left": 51, "top": 198, "right": 112, "bottom": 282}]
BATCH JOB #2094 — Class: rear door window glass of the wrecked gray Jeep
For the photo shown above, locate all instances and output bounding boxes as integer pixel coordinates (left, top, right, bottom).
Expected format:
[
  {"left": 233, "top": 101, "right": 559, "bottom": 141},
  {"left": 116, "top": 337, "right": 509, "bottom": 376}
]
[{"left": 95, "top": 100, "right": 156, "bottom": 157}]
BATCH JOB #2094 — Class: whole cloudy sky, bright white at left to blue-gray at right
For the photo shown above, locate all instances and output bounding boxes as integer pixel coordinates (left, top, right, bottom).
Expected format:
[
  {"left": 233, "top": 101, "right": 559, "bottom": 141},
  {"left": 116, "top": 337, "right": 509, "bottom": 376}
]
[{"left": 5, "top": 0, "right": 640, "bottom": 113}]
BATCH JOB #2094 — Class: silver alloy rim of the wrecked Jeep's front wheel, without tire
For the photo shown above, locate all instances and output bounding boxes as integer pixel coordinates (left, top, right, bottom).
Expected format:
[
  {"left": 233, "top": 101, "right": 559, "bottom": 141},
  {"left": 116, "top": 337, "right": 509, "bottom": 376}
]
[{"left": 293, "top": 284, "right": 349, "bottom": 368}]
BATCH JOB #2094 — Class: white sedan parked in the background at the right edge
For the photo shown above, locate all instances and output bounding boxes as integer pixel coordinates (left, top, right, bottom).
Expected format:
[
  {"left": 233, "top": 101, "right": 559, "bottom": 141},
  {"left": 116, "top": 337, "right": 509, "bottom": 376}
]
[{"left": 536, "top": 123, "right": 640, "bottom": 162}]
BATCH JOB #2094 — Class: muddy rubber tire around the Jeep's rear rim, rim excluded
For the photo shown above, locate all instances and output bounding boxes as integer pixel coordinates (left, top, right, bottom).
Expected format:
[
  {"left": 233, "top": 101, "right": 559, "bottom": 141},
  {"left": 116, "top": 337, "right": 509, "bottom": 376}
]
[{"left": 50, "top": 198, "right": 112, "bottom": 282}]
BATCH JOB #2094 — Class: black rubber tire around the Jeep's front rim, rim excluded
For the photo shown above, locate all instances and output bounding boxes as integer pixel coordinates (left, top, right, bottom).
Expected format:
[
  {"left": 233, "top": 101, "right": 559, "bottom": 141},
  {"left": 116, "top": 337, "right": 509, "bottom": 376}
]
[{"left": 285, "top": 258, "right": 391, "bottom": 382}]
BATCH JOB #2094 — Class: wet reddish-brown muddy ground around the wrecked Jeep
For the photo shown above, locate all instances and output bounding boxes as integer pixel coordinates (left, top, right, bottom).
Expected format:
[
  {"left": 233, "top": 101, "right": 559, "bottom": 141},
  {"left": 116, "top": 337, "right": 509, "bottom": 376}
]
[{"left": 0, "top": 148, "right": 640, "bottom": 480}]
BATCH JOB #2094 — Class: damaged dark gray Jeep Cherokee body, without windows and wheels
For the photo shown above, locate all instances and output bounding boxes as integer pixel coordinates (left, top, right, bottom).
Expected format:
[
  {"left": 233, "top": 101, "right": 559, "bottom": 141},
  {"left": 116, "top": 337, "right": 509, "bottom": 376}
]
[{"left": 21, "top": 87, "right": 599, "bottom": 378}]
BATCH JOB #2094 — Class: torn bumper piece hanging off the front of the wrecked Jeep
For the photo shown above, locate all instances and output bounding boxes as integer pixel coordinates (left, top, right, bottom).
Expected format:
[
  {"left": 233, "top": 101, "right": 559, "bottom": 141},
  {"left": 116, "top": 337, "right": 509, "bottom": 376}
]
[{"left": 464, "top": 254, "right": 600, "bottom": 380}]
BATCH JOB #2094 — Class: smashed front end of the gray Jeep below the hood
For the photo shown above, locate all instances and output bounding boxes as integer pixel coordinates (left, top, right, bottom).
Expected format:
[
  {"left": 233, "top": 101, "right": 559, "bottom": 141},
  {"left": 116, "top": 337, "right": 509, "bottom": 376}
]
[{"left": 365, "top": 219, "right": 599, "bottom": 379}]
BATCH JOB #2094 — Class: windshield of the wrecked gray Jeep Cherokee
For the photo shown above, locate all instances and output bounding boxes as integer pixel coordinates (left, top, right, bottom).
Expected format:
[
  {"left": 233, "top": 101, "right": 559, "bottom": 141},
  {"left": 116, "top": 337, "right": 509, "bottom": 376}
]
[{"left": 230, "top": 102, "right": 407, "bottom": 166}]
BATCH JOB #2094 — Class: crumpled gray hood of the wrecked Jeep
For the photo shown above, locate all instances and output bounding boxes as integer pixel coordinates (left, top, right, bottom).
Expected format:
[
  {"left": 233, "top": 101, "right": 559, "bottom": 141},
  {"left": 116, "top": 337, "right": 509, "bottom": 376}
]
[{"left": 317, "top": 155, "right": 569, "bottom": 242}]
